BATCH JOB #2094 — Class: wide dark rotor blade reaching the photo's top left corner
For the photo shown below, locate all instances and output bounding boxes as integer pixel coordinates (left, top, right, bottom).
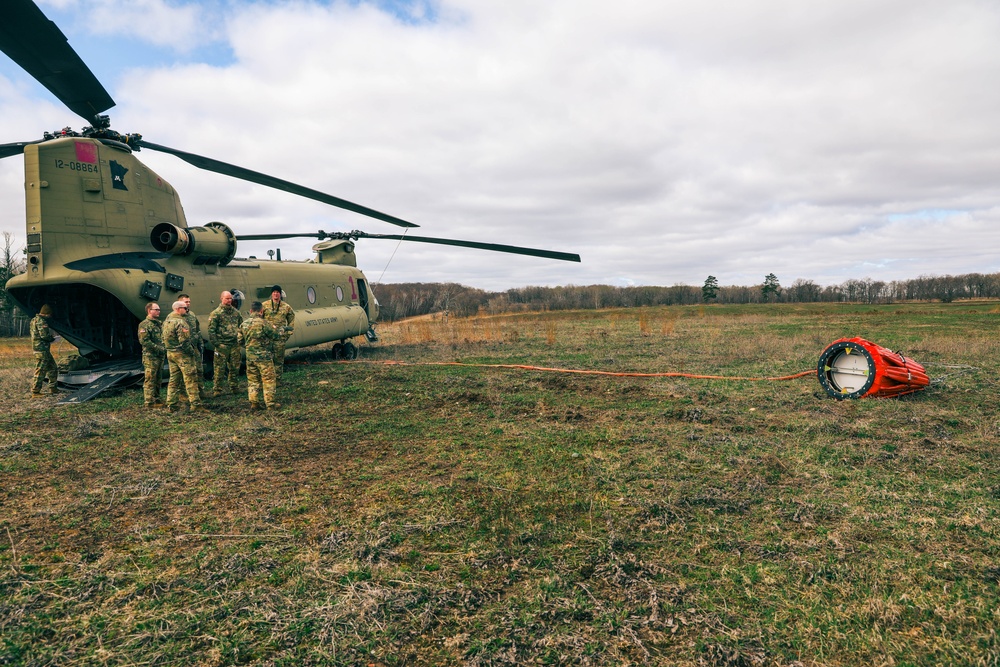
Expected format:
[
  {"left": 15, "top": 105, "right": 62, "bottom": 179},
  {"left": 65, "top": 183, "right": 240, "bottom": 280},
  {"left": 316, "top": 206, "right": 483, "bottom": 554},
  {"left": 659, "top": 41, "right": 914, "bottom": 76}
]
[{"left": 0, "top": 0, "right": 115, "bottom": 123}]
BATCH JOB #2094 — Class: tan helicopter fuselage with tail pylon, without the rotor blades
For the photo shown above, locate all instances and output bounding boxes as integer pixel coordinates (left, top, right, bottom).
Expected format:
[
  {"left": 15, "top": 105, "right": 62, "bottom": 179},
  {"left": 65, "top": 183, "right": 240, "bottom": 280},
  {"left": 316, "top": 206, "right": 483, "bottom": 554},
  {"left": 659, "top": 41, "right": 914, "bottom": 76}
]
[{"left": 7, "top": 137, "right": 378, "bottom": 358}]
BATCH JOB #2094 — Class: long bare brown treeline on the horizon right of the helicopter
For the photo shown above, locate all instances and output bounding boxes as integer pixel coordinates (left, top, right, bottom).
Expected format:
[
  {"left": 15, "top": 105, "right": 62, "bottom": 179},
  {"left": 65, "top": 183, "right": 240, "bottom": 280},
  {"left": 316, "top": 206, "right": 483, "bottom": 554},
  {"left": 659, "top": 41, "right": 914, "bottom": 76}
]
[{"left": 375, "top": 273, "right": 1000, "bottom": 320}]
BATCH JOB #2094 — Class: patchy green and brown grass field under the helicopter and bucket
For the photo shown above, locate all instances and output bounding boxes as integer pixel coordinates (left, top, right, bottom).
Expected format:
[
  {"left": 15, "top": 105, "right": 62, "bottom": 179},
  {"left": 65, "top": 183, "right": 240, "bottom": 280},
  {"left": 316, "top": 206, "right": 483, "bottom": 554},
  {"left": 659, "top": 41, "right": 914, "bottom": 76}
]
[{"left": 0, "top": 302, "right": 1000, "bottom": 667}]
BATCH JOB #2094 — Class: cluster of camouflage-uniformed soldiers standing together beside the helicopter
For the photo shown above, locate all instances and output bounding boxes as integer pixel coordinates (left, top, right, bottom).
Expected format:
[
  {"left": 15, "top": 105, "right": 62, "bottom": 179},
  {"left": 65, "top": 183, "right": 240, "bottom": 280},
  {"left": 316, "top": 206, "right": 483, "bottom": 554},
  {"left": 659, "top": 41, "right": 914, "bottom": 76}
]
[{"left": 139, "top": 285, "right": 295, "bottom": 412}]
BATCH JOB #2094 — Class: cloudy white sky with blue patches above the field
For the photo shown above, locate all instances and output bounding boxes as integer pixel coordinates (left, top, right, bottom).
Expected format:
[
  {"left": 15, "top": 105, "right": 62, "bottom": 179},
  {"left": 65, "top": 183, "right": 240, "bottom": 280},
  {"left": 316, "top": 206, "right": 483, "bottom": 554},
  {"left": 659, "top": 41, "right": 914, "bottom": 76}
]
[{"left": 0, "top": 0, "right": 1000, "bottom": 290}]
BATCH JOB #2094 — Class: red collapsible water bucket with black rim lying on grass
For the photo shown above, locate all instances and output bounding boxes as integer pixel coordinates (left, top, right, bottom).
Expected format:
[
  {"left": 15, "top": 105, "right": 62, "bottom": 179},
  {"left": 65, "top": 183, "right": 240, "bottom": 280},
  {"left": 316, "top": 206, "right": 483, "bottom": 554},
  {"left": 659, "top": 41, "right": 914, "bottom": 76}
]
[{"left": 816, "top": 338, "right": 931, "bottom": 399}]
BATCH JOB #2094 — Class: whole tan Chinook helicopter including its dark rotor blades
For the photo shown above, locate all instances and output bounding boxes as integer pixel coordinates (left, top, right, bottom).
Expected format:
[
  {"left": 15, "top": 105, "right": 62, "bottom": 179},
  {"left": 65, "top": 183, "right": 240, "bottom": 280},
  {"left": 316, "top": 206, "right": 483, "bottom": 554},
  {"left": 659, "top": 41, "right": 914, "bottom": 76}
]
[{"left": 0, "top": 0, "right": 580, "bottom": 394}]
